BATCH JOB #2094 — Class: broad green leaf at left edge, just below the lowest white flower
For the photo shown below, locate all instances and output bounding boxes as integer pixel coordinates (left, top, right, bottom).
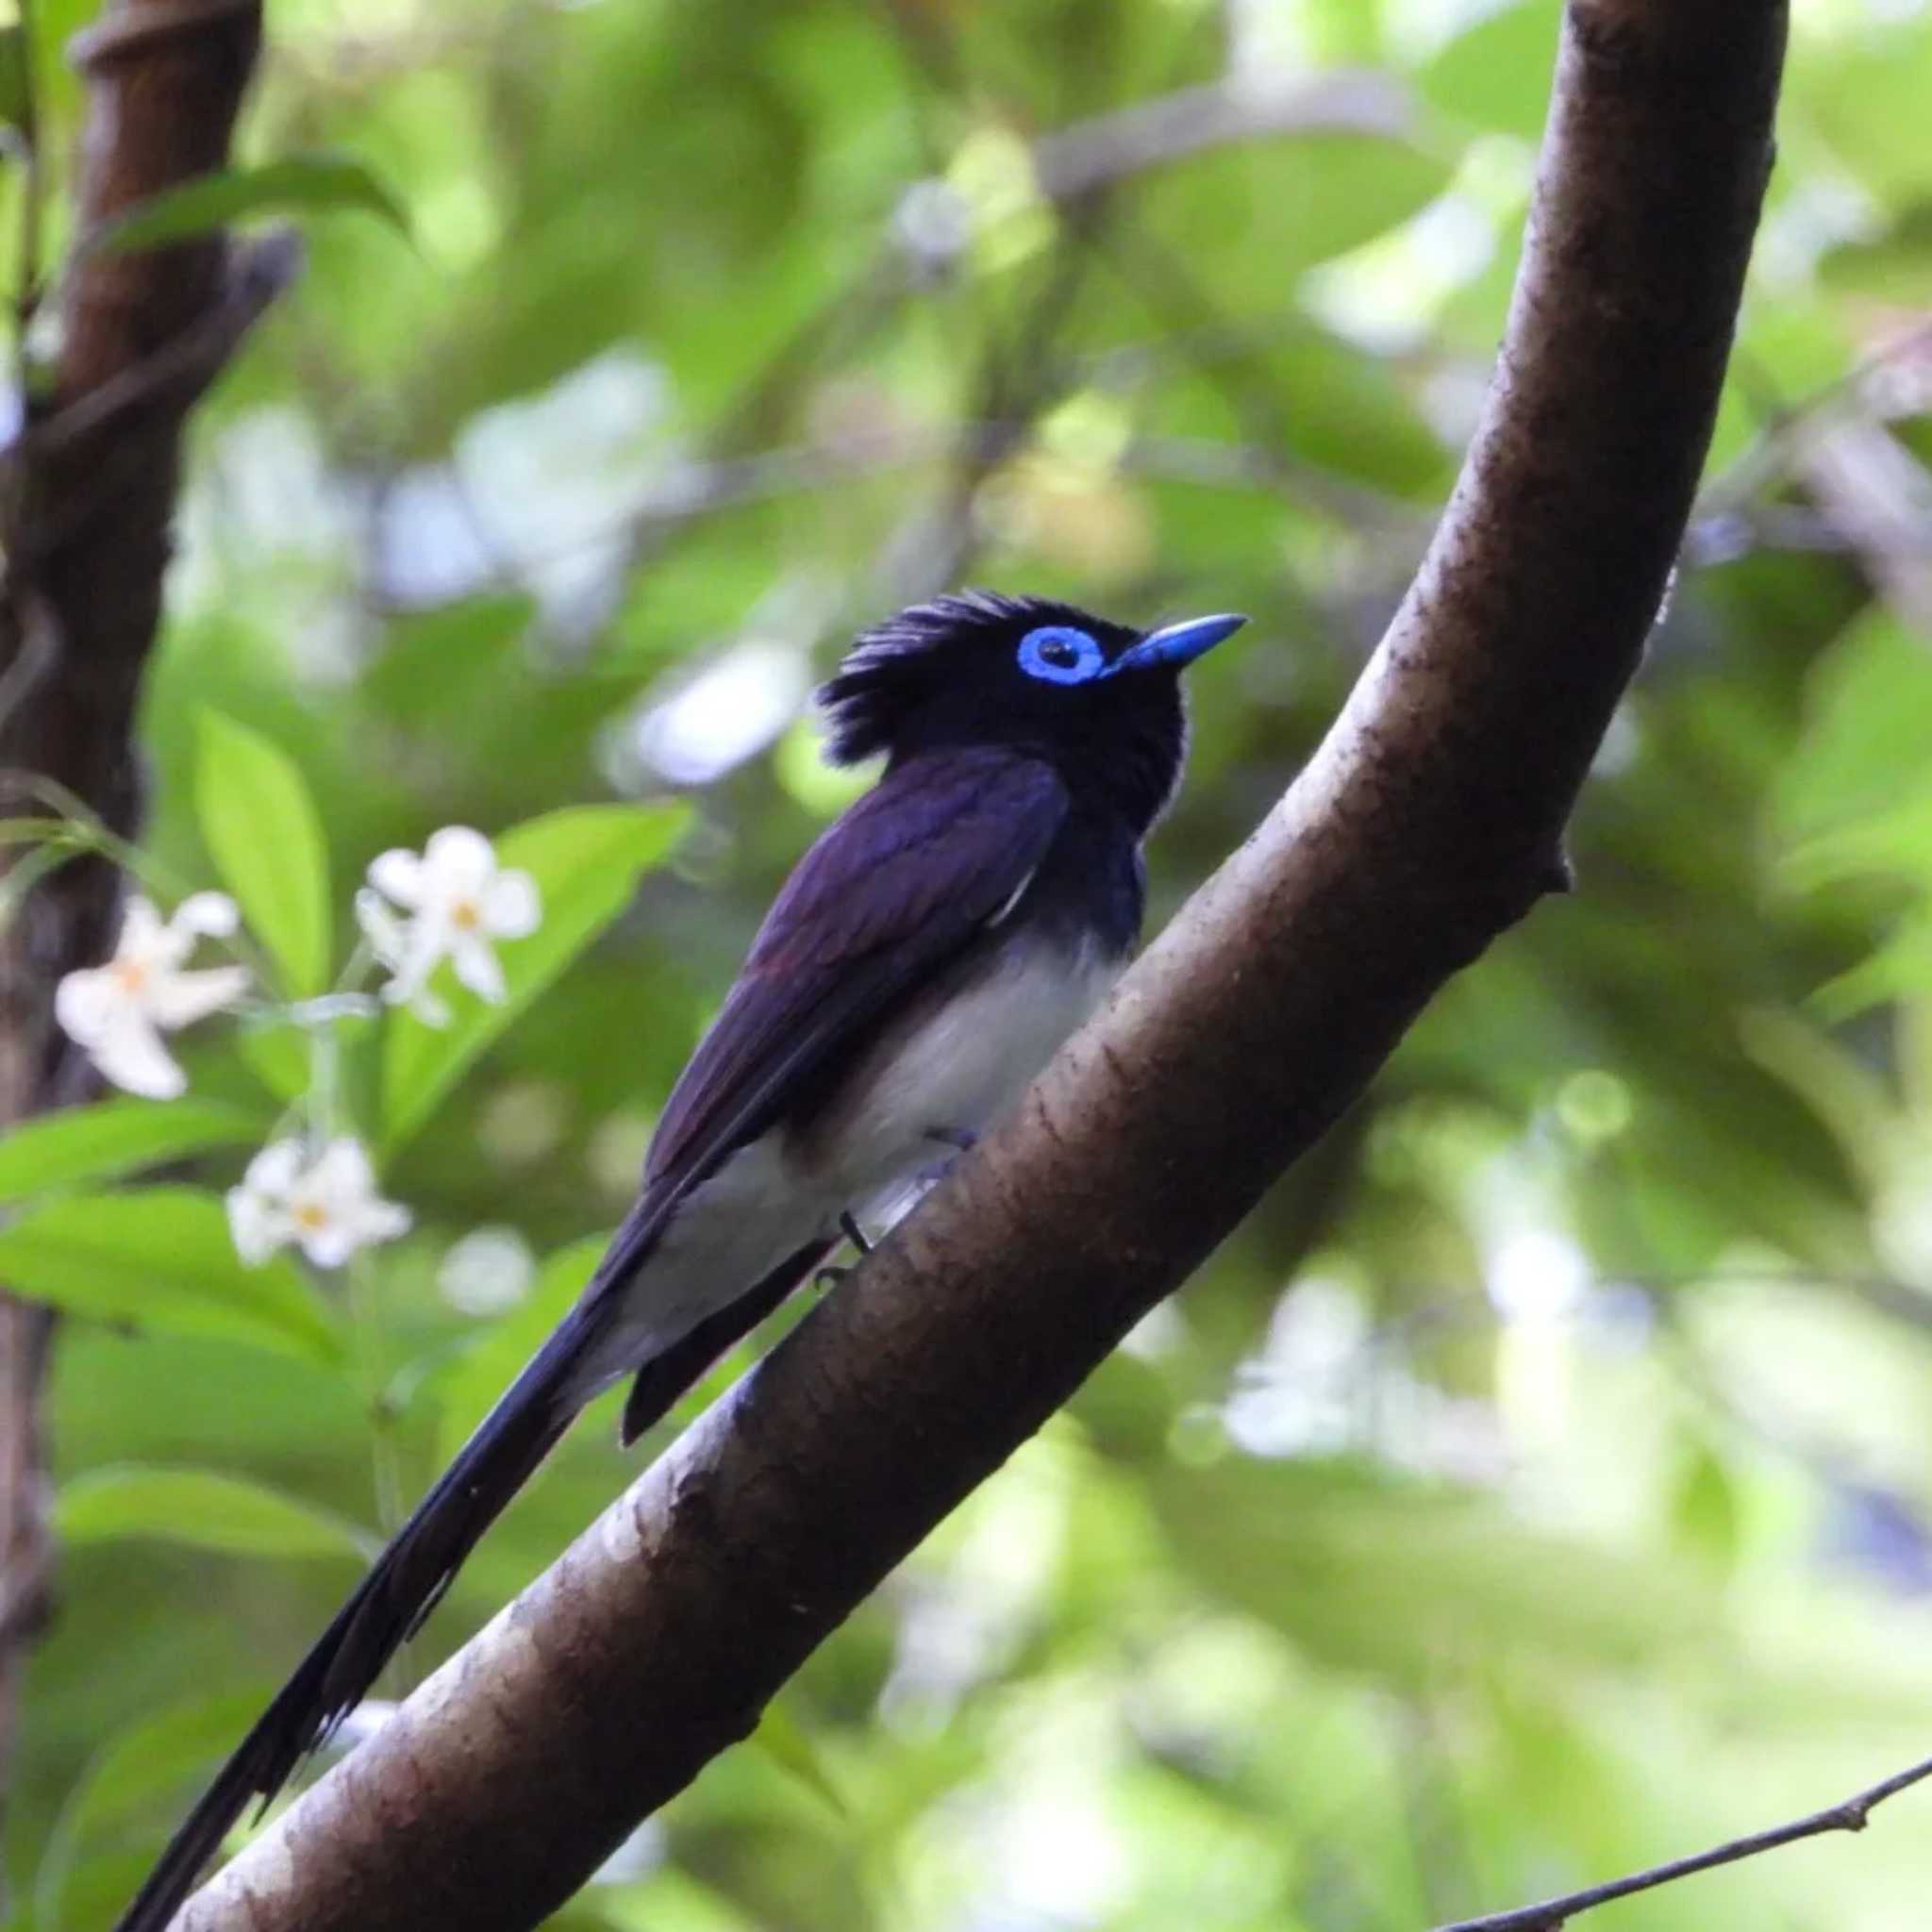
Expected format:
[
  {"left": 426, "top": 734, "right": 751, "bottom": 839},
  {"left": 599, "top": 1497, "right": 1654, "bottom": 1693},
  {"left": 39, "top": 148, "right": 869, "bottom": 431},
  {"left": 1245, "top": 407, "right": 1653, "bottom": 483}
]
[{"left": 0, "top": 1189, "right": 344, "bottom": 1368}]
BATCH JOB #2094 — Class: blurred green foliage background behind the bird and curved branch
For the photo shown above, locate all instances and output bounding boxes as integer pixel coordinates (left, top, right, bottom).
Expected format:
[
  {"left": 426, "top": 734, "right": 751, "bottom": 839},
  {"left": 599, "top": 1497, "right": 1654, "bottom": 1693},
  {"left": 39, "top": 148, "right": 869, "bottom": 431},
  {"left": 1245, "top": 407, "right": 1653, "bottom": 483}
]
[{"left": 0, "top": 0, "right": 1932, "bottom": 1932}]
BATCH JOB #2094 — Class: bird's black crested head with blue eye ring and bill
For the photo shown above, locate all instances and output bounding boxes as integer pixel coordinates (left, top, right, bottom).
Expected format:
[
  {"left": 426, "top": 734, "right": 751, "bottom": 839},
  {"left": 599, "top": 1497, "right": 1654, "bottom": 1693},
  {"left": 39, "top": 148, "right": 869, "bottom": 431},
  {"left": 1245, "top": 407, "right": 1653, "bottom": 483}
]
[{"left": 819, "top": 591, "right": 1246, "bottom": 829}]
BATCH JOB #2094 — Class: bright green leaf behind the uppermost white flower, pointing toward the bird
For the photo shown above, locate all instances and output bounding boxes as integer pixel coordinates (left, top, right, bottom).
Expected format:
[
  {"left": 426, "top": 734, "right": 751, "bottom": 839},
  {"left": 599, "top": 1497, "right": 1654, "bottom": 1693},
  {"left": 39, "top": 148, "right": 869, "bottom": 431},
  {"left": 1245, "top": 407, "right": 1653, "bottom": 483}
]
[{"left": 383, "top": 806, "right": 688, "bottom": 1156}]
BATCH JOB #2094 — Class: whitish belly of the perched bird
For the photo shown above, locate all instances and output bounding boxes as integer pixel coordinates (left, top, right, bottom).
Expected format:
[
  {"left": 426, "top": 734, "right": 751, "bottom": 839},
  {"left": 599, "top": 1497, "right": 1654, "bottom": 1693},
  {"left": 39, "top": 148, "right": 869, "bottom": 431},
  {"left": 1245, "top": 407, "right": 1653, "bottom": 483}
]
[{"left": 583, "top": 927, "right": 1121, "bottom": 1387}]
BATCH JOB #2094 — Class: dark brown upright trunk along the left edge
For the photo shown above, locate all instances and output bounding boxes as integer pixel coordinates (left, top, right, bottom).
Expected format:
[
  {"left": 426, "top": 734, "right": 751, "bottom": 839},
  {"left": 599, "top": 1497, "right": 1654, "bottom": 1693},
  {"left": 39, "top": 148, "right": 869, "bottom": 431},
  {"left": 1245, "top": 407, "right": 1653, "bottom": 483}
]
[{"left": 0, "top": 0, "right": 293, "bottom": 1870}]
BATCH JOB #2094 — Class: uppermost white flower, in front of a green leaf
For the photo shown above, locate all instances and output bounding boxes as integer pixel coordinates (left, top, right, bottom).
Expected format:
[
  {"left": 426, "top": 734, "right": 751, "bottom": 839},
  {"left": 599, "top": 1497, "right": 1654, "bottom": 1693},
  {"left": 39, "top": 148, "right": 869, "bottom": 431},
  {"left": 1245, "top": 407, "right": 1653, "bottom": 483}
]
[{"left": 356, "top": 824, "right": 539, "bottom": 1025}]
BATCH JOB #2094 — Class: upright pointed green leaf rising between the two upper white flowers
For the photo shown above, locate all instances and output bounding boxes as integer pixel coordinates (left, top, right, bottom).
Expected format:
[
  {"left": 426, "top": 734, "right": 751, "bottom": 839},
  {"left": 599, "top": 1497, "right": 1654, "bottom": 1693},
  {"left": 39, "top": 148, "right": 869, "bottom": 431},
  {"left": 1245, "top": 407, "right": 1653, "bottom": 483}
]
[{"left": 195, "top": 711, "right": 330, "bottom": 999}]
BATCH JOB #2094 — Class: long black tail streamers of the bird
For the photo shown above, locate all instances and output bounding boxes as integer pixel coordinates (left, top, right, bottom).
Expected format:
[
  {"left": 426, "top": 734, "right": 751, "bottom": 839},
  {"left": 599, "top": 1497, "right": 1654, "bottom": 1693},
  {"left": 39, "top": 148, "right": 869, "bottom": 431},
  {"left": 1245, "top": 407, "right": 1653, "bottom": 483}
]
[{"left": 116, "top": 1307, "right": 586, "bottom": 1932}]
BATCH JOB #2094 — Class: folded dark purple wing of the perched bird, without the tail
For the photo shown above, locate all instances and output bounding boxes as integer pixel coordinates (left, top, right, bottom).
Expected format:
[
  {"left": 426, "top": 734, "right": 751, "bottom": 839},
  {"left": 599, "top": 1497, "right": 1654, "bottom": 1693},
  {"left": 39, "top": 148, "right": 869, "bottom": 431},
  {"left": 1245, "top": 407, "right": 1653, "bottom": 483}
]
[{"left": 645, "top": 748, "right": 1066, "bottom": 1184}]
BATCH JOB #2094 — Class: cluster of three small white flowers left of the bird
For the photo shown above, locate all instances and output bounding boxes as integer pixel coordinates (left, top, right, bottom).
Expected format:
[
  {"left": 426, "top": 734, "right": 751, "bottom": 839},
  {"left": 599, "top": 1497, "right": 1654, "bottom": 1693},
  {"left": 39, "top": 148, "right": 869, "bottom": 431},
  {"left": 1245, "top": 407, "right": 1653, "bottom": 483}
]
[{"left": 54, "top": 824, "right": 541, "bottom": 1267}]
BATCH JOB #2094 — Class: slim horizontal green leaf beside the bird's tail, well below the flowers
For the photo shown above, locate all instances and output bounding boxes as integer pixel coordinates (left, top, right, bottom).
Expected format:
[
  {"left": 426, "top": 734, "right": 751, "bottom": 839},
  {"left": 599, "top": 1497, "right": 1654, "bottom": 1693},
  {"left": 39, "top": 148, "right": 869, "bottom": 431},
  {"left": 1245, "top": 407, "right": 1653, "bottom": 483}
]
[{"left": 54, "top": 1462, "right": 375, "bottom": 1559}]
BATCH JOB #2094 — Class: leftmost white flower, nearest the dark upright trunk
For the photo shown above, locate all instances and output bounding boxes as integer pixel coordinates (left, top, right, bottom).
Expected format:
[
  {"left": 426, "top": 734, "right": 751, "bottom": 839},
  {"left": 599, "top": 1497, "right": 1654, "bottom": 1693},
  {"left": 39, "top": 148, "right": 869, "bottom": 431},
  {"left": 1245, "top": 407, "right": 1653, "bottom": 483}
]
[{"left": 54, "top": 892, "right": 247, "bottom": 1099}]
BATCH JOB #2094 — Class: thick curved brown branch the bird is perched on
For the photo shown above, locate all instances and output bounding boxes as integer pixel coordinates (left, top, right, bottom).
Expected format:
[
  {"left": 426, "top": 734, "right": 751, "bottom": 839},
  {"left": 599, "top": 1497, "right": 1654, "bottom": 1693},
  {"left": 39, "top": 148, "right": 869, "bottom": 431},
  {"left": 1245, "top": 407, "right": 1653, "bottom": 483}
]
[{"left": 177, "top": 0, "right": 1785, "bottom": 1932}]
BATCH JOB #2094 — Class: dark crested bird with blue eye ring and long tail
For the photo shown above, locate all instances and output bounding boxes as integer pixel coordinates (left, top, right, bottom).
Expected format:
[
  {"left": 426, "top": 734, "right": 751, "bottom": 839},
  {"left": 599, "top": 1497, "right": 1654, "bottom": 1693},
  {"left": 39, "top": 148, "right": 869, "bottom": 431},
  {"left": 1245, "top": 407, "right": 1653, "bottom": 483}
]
[{"left": 116, "top": 591, "right": 1246, "bottom": 1932}]
